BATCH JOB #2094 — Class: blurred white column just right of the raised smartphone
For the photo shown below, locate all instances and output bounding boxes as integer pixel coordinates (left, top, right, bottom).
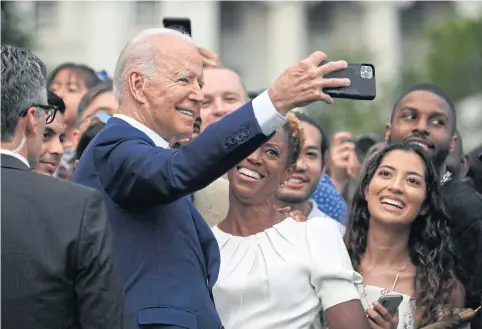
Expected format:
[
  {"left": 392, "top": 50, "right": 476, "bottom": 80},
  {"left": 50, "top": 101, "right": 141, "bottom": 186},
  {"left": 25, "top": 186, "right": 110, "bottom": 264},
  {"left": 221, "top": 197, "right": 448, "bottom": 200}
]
[{"left": 362, "top": 1, "right": 401, "bottom": 85}]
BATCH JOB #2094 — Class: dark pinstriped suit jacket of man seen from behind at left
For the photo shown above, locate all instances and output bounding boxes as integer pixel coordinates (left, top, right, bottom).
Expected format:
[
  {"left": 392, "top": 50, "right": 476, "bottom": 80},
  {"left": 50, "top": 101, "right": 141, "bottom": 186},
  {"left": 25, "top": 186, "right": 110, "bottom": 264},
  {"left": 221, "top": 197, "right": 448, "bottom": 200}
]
[{"left": 1, "top": 154, "right": 128, "bottom": 329}]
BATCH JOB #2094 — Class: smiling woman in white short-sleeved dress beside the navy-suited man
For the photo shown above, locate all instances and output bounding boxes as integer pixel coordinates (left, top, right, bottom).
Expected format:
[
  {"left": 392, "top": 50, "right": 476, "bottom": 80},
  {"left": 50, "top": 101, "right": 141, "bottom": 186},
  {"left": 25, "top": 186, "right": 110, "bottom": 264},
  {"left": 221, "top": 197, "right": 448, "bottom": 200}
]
[{"left": 213, "top": 116, "right": 369, "bottom": 329}]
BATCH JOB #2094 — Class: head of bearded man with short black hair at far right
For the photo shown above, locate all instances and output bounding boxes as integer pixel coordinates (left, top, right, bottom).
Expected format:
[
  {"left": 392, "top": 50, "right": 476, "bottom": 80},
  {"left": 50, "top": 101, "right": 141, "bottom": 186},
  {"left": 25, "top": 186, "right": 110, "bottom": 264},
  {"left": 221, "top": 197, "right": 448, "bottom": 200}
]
[{"left": 385, "top": 90, "right": 456, "bottom": 170}]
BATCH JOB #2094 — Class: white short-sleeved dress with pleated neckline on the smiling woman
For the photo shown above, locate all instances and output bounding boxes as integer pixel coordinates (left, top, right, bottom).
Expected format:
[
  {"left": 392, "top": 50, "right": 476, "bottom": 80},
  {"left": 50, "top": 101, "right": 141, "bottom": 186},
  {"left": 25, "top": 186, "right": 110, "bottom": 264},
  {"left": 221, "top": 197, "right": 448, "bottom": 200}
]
[{"left": 212, "top": 218, "right": 362, "bottom": 329}]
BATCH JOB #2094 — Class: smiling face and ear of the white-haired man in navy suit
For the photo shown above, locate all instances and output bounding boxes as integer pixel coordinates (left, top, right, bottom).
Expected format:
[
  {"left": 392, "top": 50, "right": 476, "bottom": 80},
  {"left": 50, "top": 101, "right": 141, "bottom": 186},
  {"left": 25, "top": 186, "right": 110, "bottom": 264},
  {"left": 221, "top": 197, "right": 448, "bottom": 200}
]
[{"left": 131, "top": 35, "right": 204, "bottom": 144}]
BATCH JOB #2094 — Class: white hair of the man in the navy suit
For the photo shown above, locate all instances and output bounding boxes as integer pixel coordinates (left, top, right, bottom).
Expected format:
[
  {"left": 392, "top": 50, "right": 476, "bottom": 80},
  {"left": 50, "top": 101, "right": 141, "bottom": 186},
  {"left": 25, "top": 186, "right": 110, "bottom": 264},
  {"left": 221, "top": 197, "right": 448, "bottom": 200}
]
[{"left": 113, "top": 28, "right": 194, "bottom": 101}]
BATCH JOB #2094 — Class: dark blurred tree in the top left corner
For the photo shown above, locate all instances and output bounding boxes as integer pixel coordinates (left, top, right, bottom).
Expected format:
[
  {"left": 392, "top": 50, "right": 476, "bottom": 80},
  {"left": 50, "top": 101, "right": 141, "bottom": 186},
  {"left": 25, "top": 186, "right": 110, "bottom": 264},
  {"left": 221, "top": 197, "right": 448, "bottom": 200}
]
[{"left": 1, "top": 1, "right": 33, "bottom": 48}]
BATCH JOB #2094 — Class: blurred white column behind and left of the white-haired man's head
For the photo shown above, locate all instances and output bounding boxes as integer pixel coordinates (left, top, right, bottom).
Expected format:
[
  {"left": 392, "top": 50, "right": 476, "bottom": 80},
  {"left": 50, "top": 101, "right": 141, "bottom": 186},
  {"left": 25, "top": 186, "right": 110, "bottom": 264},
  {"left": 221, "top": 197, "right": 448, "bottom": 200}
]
[{"left": 82, "top": 1, "right": 134, "bottom": 76}]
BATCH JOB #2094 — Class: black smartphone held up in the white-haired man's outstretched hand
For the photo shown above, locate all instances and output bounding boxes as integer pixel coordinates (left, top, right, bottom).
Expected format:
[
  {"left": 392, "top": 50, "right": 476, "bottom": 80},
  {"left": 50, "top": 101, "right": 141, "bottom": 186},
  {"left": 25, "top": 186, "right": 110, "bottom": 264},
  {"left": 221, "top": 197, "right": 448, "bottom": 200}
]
[{"left": 318, "top": 61, "right": 377, "bottom": 101}]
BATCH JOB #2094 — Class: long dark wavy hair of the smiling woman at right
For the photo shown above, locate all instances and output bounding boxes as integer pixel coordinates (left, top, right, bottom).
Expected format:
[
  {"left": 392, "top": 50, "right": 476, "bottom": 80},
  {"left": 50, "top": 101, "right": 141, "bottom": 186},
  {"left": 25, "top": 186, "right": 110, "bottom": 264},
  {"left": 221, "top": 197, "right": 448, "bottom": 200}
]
[{"left": 345, "top": 144, "right": 457, "bottom": 328}]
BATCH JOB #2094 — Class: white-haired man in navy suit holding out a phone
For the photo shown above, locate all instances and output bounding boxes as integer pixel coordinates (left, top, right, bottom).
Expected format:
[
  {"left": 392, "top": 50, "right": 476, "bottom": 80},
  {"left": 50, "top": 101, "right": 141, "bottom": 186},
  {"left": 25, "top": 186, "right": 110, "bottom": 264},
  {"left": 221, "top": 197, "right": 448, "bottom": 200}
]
[{"left": 73, "top": 29, "right": 354, "bottom": 329}]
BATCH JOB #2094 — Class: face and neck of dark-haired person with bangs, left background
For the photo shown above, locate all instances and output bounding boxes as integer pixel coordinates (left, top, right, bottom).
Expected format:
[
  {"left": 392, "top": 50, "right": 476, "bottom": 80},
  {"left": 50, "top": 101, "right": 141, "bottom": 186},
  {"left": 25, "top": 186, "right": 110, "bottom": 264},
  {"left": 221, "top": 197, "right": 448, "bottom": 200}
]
[{"left": 49, "top": 69, "right": 87, "bottom": 127}]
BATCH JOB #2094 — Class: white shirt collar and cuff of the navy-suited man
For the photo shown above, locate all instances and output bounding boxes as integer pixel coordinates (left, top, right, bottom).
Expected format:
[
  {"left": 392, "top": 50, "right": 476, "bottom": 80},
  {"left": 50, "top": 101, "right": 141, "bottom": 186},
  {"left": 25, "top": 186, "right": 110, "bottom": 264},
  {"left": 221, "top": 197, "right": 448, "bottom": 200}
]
[{"left": 114, "top": 90, "right": 287, "bottom": 149}]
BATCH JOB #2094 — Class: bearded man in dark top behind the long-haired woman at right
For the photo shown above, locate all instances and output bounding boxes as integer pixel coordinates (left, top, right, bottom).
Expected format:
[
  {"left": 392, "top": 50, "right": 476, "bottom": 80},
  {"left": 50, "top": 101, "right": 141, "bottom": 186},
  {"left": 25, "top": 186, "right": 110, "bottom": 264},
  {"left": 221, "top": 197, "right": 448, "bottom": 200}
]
[{"left": 385, "top": 84, "right": 482, "bottom": 328}]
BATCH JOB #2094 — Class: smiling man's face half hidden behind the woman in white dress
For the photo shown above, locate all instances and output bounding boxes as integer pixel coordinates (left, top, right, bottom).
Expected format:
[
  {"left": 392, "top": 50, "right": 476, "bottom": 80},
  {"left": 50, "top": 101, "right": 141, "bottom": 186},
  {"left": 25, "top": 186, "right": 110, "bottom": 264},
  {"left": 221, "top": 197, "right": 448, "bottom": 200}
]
[{"left": 276, "top": 122, "right": 323, "bottom": 203}]
